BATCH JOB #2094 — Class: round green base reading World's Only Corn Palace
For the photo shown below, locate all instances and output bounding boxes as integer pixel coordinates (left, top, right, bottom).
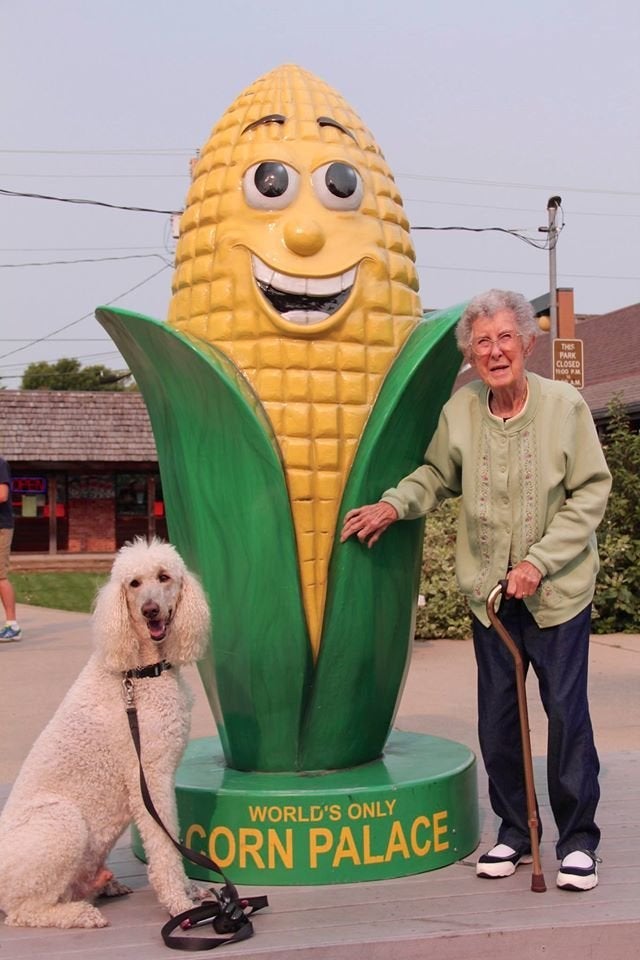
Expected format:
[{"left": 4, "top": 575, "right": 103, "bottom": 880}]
[{"left": 133, "top": 731, "right": 480, "bottom": 886}]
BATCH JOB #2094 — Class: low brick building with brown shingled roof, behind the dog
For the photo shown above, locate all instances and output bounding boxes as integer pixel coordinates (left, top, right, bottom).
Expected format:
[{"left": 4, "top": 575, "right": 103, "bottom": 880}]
[{"left": 0, "top": 390, "right": 166, "bottom": 553}]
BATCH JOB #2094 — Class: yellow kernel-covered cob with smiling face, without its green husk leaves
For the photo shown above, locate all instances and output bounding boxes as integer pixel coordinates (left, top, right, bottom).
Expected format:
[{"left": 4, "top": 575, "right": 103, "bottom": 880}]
[{"left": 169, "top": 65, "right": 421, "bottom": 657}]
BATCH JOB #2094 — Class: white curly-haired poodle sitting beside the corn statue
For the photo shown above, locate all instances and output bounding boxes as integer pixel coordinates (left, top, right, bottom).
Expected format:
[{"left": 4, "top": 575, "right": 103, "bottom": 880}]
[{"left": 0, "top": 540, "right": 209, "bottom": 927}]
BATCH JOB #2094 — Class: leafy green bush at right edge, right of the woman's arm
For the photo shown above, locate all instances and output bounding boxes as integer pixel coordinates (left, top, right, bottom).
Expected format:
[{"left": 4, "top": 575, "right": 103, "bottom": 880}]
[{"left": 593, "top": 397, "right": 640, "bottom": 633}]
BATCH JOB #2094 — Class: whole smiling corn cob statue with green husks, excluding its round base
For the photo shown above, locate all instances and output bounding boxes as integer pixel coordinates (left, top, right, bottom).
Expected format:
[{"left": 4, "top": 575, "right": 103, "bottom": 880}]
[{"left": 98, "top": 65, "right": 459, "bottom": 770}]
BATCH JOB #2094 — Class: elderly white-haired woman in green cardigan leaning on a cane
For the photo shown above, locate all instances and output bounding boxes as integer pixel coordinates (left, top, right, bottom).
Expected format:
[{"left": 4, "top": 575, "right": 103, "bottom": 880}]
[{"left": 342, "top": 290, "right": 611, "bottom": 890}]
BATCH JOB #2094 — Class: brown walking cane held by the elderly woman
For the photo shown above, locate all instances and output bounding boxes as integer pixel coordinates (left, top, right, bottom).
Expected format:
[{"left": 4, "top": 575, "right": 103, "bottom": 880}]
[{"left": 487, "top": 580, "right": 547, "bottom": 893}]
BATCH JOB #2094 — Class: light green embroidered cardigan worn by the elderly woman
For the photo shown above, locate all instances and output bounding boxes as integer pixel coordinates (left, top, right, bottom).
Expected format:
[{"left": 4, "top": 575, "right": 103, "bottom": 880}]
[{"left": 381, "top": 373, "right": 611, "bottom": 627}]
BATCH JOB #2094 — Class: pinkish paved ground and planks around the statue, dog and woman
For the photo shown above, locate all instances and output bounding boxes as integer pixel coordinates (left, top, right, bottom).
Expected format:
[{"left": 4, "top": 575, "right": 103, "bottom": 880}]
[{"left": 0, "top": 606, "right": 640, "bottom": 960}]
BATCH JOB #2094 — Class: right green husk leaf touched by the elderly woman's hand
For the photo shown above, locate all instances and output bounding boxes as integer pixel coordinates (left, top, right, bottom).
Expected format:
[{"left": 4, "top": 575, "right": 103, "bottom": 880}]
[{"left": 302, "top": 306, "right": 463, "bottom": 770}]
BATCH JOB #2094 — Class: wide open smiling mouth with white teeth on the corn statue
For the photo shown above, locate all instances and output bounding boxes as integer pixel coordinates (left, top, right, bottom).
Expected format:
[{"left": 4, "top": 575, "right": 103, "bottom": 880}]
[{"left": 251, "top": 254, "right": 357, "bottom": 327}]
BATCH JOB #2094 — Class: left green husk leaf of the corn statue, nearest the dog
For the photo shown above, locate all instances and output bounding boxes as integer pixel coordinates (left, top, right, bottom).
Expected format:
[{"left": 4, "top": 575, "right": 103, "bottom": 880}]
[{"left": 96, "top": 308, "right": 312, "bottom": 771}]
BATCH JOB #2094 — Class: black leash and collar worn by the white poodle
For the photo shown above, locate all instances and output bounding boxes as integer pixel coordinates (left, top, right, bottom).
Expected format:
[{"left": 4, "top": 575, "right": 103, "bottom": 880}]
[{"left": 122, "top": 672, "right": 269, "bottom": 951}]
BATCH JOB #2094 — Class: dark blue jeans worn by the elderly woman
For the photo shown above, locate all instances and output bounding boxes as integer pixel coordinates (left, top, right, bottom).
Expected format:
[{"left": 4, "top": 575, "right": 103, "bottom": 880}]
[{"left": 473, "top": 599, "right": 600, "bottom": 859}]
